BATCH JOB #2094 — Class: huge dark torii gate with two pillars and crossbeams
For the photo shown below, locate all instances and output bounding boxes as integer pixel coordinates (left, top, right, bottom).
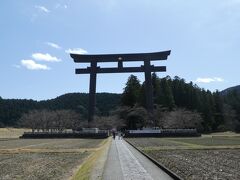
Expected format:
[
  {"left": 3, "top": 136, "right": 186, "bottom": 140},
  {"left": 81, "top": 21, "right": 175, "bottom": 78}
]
[{"left": 70, "top": 51, "right": 171, "bottom": 126}]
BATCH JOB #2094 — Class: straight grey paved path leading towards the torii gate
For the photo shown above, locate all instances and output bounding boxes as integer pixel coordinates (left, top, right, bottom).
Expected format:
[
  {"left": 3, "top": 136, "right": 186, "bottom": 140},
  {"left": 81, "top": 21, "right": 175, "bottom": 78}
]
[{"left": 103, "top": 137, "right": 172, "bottom": 180}]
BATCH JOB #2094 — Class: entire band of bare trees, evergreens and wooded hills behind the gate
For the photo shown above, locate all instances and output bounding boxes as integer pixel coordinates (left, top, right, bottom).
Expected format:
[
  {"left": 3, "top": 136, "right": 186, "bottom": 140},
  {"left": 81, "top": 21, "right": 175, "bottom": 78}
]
[{"left": 0, "top": 73, "right": 240, "bottom": 132}]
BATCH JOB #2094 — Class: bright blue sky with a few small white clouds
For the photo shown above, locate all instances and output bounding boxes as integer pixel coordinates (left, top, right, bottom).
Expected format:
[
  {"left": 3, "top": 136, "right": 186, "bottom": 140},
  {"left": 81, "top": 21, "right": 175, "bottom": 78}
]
[{"left": 0, "top": 0, "right": 240, "bottom": 100}]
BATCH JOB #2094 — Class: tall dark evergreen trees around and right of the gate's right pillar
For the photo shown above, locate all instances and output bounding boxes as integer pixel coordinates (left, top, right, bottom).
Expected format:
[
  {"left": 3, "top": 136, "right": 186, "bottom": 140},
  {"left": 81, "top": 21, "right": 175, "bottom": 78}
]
[{"left": 122, "top": 73, "right": 240, "bottom": 132}]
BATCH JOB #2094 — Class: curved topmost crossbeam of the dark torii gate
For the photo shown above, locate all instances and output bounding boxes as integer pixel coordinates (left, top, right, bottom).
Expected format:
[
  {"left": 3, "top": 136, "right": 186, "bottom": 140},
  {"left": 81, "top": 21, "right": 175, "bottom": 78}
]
[{"left": 70, "top": 51, "right": 171, "bottom": 63}]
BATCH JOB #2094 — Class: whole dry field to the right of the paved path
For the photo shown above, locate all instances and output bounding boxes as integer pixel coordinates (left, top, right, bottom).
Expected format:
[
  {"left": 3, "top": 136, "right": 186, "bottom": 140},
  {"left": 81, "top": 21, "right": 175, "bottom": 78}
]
[{"left": 128, "top": 133, "right": 240, "bottom": 180}]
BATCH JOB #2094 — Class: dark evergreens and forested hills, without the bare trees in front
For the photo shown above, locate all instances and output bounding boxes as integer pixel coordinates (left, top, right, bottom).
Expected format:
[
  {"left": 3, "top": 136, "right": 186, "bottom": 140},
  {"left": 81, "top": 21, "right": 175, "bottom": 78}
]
[{"left": 0, "top": 73, "right": 240, "bottom": 132}]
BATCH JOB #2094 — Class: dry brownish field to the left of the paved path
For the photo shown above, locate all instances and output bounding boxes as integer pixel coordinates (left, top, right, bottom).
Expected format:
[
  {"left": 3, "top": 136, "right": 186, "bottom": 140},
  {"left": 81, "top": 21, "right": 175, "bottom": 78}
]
[{"left": 0, "top": 130, "right": 105, "bottom": 180}]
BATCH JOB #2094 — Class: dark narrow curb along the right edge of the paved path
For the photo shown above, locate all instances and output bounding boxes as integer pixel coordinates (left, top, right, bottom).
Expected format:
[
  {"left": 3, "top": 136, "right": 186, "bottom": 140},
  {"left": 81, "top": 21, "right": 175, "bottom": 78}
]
[{"left": 124, "top": 139, "right": 182, "bottom": 180}]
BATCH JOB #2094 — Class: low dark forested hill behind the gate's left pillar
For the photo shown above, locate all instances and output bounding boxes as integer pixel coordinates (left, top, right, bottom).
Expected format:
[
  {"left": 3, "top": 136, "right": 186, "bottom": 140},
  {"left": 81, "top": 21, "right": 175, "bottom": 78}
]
[{"left": 0, "top": 93, "right": 121, "bottom": 126}]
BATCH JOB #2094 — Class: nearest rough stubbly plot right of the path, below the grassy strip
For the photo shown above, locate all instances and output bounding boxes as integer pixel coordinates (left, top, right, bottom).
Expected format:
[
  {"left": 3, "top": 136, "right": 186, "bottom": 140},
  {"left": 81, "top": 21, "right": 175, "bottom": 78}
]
[{"left": 145, "top": 149, "right": 240, "bottom": 180}]
